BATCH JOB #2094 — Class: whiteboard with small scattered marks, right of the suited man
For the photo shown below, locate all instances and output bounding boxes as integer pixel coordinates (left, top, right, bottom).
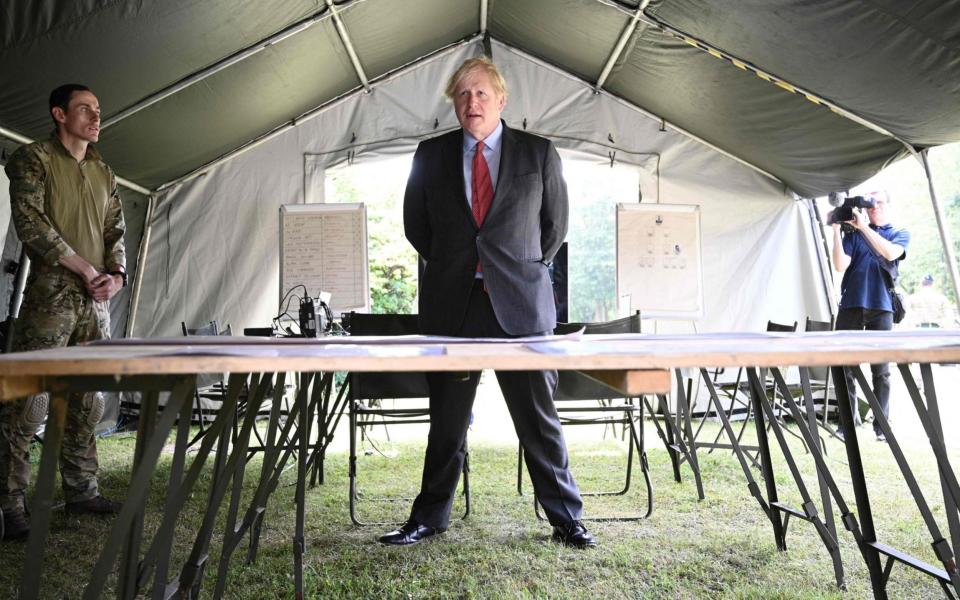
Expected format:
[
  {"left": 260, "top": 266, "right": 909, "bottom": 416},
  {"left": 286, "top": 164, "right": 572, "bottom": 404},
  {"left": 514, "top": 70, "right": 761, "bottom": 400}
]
[{"left": 617, "top": 204, "right": 703, "bottom": 320}]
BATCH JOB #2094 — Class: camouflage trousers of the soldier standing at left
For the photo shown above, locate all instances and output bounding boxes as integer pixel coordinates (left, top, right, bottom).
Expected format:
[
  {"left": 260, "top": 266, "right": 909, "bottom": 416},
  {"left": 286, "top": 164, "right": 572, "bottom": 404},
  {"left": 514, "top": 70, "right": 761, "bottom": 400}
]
[{"left": 0, "top": 263, "right": 110, "bottom": 511}]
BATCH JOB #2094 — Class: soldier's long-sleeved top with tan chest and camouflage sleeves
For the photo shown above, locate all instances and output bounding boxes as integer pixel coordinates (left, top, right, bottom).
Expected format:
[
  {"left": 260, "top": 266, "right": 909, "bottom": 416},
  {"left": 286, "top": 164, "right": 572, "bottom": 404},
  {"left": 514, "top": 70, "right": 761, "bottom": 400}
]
[{"left": 6, "top": 132, "right": 126, "bottom": 272}]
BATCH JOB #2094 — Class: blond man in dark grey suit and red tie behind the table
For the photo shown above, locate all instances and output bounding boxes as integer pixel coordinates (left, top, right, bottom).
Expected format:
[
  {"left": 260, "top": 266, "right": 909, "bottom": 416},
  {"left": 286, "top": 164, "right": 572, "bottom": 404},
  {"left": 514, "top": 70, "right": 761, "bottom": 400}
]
[{"left": 379, "top": 58, "right": 597, "bottom": 548}]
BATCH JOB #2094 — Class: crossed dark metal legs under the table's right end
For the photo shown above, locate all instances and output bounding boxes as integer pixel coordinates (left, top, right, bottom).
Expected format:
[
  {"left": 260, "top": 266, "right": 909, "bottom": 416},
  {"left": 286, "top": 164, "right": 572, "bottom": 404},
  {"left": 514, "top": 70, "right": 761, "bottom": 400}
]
[{"left": 662, "top": 363, "right": 960, "bottom": 599}]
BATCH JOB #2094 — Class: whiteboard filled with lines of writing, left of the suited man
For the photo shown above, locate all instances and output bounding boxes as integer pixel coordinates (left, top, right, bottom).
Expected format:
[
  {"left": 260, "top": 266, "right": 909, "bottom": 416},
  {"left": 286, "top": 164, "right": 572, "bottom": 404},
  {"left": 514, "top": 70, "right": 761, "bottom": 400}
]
[{"left": 280, "top": 203, "right": 370, "bottom": 314}]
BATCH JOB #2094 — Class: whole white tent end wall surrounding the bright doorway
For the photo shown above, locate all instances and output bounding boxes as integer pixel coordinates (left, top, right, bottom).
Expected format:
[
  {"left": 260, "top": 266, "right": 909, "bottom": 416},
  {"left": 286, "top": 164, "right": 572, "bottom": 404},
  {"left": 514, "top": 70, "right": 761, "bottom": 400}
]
[{"left": 130, "top": 40, "right": 829, "bottom": 337}]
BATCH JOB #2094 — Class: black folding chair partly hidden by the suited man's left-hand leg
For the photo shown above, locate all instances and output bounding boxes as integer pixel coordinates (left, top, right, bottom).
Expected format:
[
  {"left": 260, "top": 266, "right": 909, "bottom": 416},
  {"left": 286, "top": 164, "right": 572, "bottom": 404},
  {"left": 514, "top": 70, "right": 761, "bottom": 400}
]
[{"left": 344, "top": 312, "right": 470, "bottom": 525}]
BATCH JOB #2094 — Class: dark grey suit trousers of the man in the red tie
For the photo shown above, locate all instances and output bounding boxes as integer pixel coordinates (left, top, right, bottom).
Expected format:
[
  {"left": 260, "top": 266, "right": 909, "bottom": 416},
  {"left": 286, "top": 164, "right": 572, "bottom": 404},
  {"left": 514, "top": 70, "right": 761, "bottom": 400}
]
[{"left": 410, "top": 280, "right": 583, "bottom": 529}]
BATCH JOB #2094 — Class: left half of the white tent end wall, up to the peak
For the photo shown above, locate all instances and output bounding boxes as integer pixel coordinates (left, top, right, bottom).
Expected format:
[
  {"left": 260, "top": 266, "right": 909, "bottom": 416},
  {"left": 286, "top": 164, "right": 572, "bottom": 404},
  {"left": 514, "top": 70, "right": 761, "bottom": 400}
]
[{"left": 130, "top": 46, "right": 476, "bottom": 337}]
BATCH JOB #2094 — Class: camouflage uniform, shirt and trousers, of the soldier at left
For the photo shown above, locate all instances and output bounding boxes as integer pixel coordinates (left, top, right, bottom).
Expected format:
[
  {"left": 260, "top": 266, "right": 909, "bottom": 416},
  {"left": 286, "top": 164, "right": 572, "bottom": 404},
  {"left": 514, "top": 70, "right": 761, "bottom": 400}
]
[{"left": 0, "top": 133, "right": 126, "bottom": 511}]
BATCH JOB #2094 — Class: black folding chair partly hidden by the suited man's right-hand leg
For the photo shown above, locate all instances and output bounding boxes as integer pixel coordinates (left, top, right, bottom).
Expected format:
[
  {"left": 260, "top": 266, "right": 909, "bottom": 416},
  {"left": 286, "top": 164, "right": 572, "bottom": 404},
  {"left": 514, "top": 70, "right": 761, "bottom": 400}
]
[{"left": 517, "top": 312, "right": 653, "bottom": 521}]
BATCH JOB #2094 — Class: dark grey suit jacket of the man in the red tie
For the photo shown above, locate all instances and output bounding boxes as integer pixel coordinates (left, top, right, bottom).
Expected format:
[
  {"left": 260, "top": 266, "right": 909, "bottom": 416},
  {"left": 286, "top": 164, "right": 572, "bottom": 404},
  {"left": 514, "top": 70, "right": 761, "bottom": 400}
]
[{"left": 403, "top": 125, "right": 569, "bottom": 335}]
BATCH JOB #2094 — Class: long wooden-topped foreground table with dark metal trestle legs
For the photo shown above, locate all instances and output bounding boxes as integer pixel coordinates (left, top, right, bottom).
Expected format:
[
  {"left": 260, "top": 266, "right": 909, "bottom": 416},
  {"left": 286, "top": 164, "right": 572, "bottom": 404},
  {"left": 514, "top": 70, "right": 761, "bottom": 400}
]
[{"left": 0, "top": 332, "right": 960, "bottom": 598}]
